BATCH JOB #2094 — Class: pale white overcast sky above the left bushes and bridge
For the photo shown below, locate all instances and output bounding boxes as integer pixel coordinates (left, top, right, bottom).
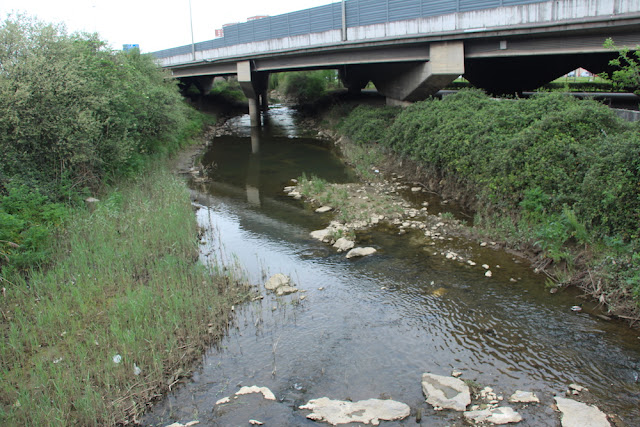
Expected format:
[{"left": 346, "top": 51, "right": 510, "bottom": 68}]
[{"left": 0, "top": 0, "right": 339, "bottom": 52}]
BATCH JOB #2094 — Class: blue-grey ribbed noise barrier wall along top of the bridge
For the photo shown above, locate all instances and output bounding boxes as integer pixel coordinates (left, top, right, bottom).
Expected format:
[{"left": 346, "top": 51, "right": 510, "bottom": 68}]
[{"left": 153, "top": 0, "right": 544, "bottom": 58}]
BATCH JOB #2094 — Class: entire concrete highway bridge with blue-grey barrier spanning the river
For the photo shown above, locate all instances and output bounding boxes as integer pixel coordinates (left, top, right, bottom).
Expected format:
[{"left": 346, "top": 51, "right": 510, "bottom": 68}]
[{"left": 154, "top": 0, "right": 640, "bottom": 125}]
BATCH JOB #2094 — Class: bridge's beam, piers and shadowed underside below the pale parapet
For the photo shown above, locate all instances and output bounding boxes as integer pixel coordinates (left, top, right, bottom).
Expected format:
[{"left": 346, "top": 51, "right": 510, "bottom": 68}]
[{"left": 173, "top": 25, "right": 640, "bottom": 126}]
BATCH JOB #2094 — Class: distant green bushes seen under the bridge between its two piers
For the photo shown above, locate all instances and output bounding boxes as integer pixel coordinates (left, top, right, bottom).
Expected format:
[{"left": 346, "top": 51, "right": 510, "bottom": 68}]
[{"left": 269, "top": 70, "right": 341, "bottom": 104}]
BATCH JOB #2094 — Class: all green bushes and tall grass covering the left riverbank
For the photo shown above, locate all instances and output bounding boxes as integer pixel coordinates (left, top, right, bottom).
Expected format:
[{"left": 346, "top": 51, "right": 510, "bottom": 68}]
[{"left": 0, "top": 16, "right": 245, "bottom": 426}]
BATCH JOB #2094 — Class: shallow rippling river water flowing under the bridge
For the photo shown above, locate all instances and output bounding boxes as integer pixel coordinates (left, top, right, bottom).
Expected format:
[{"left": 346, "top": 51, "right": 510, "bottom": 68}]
[{"left": 144, "top": 107, "right": 640, "bottom": 426}]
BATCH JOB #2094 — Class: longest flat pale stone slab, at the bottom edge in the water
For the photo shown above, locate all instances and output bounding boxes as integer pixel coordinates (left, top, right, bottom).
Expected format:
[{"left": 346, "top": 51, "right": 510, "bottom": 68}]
[{"left": 300, "top": 397, "right": 411, "bottom": 426}]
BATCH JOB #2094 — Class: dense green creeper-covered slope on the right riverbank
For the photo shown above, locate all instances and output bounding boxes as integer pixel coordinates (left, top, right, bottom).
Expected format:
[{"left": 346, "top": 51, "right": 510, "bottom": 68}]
[{"left": 340, "top": 91, "right": 640, "bottom": 316}]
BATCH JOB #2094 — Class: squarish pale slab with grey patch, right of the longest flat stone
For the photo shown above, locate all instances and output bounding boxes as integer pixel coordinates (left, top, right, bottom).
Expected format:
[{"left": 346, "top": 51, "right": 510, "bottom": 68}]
[{"left": 422, "top": 373, "right": 471, "bottom": 411}]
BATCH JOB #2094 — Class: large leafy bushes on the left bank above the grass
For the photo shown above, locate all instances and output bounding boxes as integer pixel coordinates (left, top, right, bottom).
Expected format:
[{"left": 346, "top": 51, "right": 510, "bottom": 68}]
[{"left": 0, "top": 16, "right": 202, "bottom": 274}]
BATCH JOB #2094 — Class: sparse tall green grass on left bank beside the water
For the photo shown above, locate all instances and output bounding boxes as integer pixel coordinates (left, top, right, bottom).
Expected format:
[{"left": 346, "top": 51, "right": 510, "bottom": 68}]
[{"left": 0, "top": 163, "right": 245, "bottom": 426}]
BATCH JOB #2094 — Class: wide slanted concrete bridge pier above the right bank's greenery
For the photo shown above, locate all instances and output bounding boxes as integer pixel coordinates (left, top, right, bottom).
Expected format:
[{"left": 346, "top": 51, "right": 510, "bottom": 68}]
[{"left": 371, "top": 41, "right": 464, "bottom": 105}]
